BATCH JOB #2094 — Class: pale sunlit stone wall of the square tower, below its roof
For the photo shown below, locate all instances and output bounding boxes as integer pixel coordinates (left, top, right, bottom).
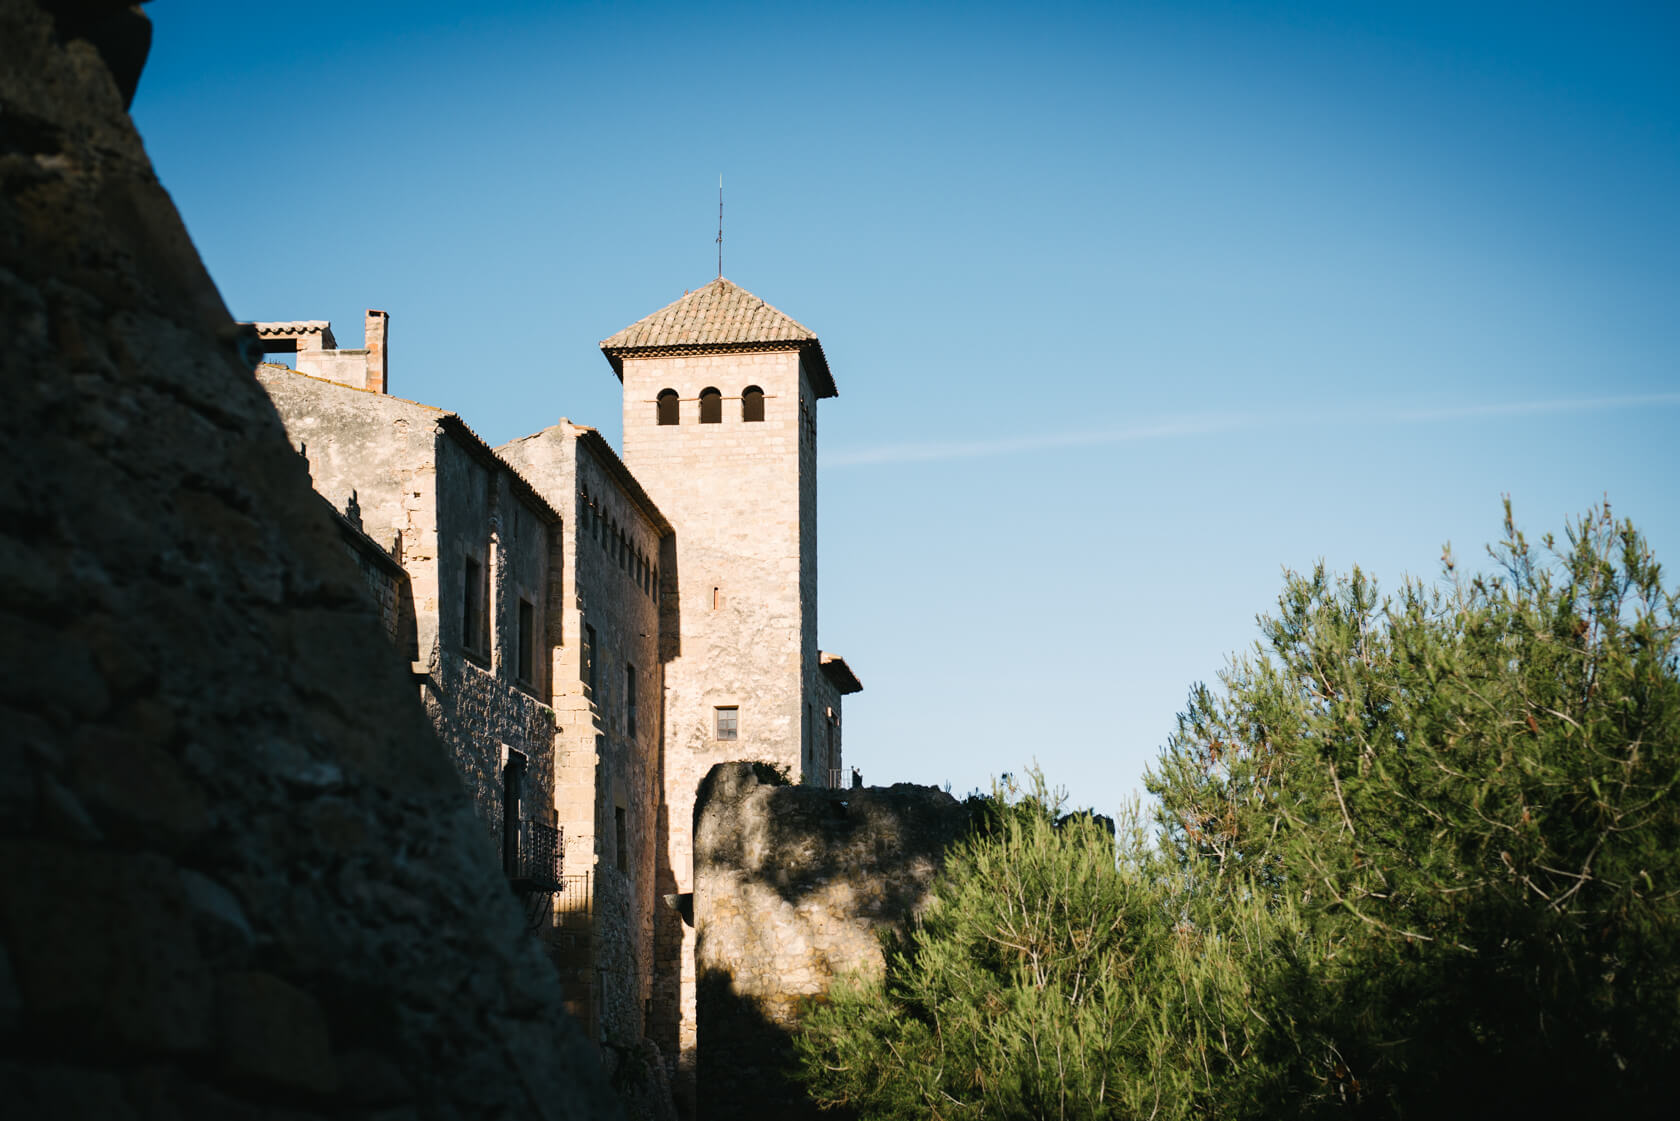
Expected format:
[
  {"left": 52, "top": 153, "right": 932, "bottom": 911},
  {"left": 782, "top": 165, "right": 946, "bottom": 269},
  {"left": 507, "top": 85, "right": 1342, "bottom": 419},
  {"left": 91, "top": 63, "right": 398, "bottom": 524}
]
[{"left": 623, "top": 350, "right": 816, "bottom": 1094}]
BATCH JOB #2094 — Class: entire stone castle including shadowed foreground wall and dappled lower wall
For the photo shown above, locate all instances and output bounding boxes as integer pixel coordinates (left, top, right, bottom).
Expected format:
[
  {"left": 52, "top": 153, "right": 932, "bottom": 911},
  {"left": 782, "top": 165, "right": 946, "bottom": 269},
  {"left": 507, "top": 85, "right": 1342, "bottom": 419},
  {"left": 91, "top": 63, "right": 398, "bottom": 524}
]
[{"left": 0, "top": 0, "right": 963, "bottom": 1121}]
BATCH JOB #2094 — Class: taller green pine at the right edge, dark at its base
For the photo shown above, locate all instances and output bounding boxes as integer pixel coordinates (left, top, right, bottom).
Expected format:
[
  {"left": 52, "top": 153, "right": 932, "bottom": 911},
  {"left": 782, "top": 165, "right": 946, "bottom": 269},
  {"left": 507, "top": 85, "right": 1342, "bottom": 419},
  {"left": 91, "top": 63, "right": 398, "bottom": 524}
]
[{"left": 1149, "top": 504, "right": 1680, "bottom": 1116}]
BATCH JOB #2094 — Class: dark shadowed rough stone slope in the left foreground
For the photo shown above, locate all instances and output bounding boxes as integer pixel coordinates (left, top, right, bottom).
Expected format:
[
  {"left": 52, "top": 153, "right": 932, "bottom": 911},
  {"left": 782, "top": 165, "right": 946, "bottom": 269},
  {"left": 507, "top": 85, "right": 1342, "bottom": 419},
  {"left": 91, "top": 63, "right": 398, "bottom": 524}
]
[{"left": 0, "top": 0, "right": 617, "bottom": 1119}]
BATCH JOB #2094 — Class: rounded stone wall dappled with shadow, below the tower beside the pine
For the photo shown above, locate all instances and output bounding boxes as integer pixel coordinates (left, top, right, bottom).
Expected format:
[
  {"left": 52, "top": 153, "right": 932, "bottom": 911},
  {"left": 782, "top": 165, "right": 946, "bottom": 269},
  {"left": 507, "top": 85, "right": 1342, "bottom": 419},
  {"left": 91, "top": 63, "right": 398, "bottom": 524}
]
[{"left": 694, "top": 763, "right": 971, "bottom": 1119}]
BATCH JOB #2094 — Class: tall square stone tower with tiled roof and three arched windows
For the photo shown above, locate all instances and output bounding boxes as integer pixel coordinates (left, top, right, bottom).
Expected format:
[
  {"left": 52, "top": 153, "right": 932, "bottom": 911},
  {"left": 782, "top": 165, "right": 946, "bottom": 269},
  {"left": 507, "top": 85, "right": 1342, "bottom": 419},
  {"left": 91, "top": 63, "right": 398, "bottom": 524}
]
[{"left": 601, "top": 277, "right": 860, "bottom": 1089}]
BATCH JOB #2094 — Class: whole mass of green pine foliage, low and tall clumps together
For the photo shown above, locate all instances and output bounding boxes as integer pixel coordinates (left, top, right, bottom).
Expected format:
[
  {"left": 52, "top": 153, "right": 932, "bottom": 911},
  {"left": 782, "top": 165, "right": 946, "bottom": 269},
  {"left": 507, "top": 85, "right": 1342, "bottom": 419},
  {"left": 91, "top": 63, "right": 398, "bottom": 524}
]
[{"left": 800, "top": 504, "right": 1680, "bottom": 1118}]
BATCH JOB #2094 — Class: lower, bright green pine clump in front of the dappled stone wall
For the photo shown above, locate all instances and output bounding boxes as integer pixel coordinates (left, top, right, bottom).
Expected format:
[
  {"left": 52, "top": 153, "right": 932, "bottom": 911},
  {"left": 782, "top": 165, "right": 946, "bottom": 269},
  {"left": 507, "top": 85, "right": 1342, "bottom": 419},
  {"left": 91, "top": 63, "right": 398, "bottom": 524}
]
[{"left": 796, "top": 771, "right": 1277, "bottom": 1119}]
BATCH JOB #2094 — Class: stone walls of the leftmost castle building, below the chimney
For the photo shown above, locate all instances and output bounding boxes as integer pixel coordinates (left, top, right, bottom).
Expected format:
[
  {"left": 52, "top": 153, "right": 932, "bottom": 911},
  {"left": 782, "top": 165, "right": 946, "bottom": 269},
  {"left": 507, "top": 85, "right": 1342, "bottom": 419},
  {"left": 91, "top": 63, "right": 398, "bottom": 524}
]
[{"left": 257, "top": 365, "right": 561, "bottom": 847}]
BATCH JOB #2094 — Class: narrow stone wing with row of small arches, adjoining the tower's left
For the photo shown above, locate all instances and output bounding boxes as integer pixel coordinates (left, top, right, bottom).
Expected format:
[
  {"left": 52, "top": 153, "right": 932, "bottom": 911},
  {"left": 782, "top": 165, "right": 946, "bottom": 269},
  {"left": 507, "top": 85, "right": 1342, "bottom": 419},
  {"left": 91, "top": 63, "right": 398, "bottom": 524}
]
[{"left": 497, "top": 420, "right": 670, "bottom": 1047}]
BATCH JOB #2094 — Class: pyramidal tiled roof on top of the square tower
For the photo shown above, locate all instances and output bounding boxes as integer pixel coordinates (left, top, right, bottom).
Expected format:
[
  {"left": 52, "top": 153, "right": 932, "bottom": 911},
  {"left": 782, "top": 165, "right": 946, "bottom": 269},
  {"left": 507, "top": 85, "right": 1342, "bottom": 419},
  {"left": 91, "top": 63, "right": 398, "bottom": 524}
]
[{"left": 601, "top": 277, "right": 838, "bottom": 397}]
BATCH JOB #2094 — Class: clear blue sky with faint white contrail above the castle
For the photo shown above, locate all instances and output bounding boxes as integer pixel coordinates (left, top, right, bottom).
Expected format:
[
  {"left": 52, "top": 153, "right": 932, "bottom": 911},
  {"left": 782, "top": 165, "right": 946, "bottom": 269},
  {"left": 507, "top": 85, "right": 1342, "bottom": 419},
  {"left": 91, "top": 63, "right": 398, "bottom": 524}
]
[{"left": 134, "top": 0, "right": 1680, "bottom": 820}]
